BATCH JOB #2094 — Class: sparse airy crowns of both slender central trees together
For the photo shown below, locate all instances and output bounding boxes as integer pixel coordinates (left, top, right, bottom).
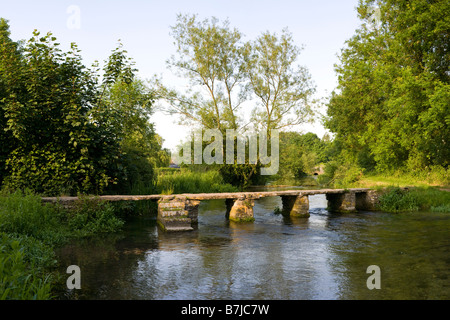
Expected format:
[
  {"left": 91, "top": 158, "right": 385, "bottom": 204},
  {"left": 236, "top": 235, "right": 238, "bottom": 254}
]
[{"left": 155, "top": 15, "right": 314, "bottom": 136}]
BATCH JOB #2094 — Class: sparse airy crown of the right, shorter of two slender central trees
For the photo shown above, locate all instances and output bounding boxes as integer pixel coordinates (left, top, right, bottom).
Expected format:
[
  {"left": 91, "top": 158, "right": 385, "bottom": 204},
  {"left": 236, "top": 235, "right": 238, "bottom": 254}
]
[{"left": 246, "top": 29, "right": 314, "bottom": 133}]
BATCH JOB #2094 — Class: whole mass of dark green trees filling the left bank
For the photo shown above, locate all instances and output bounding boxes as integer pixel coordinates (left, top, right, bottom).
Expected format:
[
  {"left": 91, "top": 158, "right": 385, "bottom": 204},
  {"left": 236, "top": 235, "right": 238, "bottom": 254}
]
[{"left": 0, "top": 19, "right": 163, "bottom": 196}]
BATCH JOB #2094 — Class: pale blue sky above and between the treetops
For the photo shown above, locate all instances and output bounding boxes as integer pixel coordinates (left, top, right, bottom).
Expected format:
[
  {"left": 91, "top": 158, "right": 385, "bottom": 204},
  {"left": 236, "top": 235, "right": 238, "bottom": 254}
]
[{"left": 0, "top": 0, "right": 360, "bottom": 148}]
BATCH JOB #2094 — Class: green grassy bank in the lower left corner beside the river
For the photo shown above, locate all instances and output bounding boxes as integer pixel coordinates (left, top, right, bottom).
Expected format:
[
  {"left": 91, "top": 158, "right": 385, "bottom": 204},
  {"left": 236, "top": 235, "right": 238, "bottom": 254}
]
[{"left": 0, "top": 191, "right": 123, "bottom": 300}]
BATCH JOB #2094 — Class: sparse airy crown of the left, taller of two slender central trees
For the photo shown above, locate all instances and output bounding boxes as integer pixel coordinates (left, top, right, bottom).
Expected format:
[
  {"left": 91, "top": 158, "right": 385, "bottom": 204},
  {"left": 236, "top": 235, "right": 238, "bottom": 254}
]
[{"left": 157, "top": 15, "right": 245, "bottom": 132}]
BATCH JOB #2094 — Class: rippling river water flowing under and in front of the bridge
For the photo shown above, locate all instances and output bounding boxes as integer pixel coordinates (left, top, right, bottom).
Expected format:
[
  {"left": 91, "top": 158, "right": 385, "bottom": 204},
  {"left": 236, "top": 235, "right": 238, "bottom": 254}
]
[{"left": 53, "top": 195, "right": 450, "bottom": 300}]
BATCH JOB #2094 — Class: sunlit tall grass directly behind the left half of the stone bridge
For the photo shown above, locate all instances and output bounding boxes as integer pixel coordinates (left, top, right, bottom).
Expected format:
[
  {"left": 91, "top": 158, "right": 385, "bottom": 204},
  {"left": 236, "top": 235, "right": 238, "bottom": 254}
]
[{"left": 156, "top": 169, "right": 238, "bottom": 194}]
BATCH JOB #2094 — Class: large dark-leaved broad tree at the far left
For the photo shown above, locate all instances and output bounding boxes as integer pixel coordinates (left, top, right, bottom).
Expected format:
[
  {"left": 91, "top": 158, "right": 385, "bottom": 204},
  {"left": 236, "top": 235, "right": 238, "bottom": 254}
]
[{"left": 1, "top": 24, "right": 123, "bottom": 194}]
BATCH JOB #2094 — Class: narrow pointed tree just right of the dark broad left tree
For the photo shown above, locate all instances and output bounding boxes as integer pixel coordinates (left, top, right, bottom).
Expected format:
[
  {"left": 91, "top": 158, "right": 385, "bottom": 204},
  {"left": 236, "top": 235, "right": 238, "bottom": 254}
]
[{"left": 96, "top": 42, "right": 168, "bottom": 192}]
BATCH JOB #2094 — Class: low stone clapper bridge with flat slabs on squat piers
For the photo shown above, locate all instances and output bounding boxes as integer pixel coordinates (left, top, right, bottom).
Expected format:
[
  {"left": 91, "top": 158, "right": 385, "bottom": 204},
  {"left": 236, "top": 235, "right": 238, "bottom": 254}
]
[{"left": 42, "top": 188, "right": 379, "bottom": 231}]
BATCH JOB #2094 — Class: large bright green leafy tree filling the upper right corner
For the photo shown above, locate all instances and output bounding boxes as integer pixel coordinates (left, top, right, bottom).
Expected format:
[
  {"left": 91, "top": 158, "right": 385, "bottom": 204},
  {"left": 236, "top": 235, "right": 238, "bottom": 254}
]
[{"left": 327, "top": 0, "right": 450, "bottom": 171}]
